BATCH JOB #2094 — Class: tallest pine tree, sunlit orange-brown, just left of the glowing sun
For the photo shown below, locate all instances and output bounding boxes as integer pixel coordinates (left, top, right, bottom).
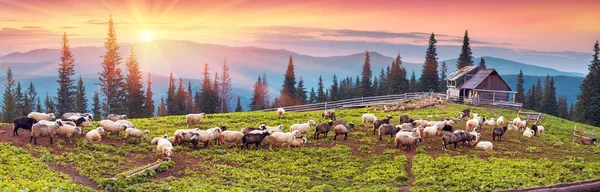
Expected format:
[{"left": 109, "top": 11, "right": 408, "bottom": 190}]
[{"left": 99, "top": 16, "right": 125, "bottom": 114}]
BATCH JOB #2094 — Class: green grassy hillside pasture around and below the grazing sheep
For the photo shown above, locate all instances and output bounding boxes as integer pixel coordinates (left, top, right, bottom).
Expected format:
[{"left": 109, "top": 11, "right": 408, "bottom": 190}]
[{"left": 0, "top": 105, "right": 600, "bottom": 191}]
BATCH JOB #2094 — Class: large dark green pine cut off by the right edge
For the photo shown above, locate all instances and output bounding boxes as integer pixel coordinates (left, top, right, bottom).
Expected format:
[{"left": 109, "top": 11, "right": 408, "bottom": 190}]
[{"left": 574, "top": 40, "right": 600, "bottom": 126}]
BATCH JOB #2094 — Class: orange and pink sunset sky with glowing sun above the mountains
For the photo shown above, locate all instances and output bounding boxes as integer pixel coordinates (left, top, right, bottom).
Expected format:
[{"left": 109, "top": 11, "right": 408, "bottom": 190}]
[{"left": 0, "top": 0, "right": 600, "bottom": 56}]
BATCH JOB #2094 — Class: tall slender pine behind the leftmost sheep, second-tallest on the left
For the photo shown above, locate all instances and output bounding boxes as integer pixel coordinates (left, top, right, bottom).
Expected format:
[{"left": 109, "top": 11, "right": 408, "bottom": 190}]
[{"left": 56, "top": 33, "right": 75, "bottom": 114}]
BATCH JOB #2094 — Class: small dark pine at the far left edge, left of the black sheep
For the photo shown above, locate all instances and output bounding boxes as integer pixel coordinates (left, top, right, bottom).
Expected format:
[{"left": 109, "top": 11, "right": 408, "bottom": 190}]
[{"left": 2, "top": 66, "right": 19, "bottom": 123}]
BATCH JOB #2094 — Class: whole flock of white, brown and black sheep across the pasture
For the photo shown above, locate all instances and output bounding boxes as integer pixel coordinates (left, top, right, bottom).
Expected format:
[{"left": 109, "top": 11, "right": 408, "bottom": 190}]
[{"left": 8, "top": 108, "right": 544, "bottom": 158}]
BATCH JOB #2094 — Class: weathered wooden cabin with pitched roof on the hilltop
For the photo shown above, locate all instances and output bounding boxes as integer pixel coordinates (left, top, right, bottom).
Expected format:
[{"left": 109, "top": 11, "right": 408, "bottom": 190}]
[{"left": 446, "top": 66, "right": 521, "bottom": 107}]
